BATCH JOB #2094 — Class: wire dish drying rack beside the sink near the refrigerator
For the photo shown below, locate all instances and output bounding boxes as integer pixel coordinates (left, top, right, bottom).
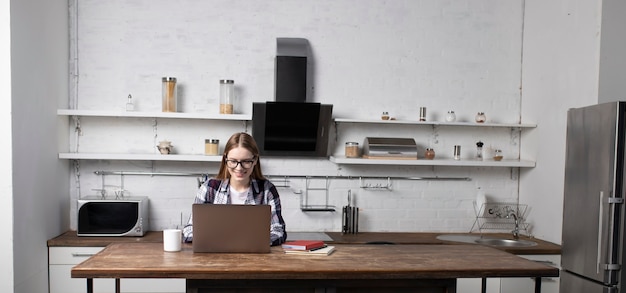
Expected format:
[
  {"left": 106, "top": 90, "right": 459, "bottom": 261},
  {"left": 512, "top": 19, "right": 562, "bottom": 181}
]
[{"left": 470, "top": 202, "right": 529, "bottom": 236}]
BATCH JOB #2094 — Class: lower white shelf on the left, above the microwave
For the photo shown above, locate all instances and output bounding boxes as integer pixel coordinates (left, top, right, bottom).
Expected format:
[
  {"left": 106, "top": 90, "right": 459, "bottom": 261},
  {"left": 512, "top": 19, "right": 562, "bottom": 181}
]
[{"left": 59, "top": 153, "right": 222, "bottom": 162}]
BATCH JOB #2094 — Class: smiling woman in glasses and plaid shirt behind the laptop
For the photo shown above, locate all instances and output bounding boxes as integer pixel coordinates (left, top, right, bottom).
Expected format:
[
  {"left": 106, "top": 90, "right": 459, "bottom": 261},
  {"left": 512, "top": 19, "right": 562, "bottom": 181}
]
[{"left": 183, "top": 132, "right": 287, "bottom": 246}]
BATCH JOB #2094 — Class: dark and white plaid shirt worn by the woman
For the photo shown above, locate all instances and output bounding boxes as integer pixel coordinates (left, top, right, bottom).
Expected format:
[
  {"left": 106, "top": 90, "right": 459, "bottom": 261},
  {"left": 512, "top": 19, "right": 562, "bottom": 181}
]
[{"left": 183, "top": 179, "right": 287, "bottom": 245}]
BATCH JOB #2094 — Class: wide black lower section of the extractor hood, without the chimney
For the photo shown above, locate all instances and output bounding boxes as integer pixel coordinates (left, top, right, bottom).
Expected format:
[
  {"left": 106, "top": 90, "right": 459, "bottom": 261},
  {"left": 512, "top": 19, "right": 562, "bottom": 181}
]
[{"left": 252, "top": 102, "right": 333, "bottom": 157}]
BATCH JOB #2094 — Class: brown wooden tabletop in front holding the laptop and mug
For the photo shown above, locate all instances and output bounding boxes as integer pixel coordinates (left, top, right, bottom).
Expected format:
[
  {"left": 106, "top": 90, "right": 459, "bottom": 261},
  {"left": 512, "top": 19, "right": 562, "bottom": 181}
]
[{"left": 71, "top": 243, "right": 559, "bottom": 279}]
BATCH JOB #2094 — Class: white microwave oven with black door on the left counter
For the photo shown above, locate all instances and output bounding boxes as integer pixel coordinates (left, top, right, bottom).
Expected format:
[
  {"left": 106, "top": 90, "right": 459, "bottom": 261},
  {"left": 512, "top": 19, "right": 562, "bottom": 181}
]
[{"left": 76, "top": 196, "right": 149, "bottom": 236}]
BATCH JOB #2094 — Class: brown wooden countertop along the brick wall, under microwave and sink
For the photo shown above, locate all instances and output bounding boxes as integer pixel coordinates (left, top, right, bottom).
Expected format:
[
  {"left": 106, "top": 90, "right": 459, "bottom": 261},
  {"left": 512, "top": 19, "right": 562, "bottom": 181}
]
[{"left": 48, "top": 231, "right": 561, "bottom": 255}]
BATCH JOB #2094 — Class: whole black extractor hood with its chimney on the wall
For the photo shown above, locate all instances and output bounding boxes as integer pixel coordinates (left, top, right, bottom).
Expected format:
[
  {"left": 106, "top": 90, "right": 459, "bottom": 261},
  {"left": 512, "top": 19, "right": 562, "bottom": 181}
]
[{"left": 252, "top": 38, "right": 333, "bottom": 157}]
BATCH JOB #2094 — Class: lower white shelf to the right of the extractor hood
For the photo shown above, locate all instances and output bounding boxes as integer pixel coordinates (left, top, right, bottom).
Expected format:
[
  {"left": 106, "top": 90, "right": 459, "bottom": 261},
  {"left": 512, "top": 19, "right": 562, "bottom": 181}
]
[{"left": 330, "top": 156, "right": 535, "bottom": 168}]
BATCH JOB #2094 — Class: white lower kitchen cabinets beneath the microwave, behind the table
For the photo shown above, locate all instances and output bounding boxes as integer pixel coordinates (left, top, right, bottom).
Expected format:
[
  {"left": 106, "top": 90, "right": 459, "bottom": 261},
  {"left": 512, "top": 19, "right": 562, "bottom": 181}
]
[{"left": 48, "top": 246, "right": 185, "bottom": 293}]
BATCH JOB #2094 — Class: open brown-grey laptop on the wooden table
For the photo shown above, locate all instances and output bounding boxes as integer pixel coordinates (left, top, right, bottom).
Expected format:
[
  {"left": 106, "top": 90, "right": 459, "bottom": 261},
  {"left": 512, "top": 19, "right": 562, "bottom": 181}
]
[{"left": 192, "top": 204, "right": 271, "bottom": 253}]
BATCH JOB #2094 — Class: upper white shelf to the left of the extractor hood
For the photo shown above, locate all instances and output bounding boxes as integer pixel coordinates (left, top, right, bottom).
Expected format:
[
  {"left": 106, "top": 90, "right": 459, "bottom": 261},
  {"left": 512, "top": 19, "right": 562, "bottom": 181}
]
[{"left": 57, "top": 109, "right": 252, "bottom": 121}]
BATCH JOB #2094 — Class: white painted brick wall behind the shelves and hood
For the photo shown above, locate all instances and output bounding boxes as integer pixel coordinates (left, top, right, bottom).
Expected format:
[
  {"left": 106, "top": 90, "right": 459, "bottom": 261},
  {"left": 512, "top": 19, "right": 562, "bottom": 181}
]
[{"left": 70, "top": 0, "right": 528, "bottom": 231}]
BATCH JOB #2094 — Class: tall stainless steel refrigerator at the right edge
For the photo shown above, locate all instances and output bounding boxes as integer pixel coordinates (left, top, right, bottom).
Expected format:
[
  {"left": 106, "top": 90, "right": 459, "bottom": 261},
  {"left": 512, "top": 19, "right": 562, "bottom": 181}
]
[{"left": 560, "top": 102, "right": 626, "bottom": 293}]
